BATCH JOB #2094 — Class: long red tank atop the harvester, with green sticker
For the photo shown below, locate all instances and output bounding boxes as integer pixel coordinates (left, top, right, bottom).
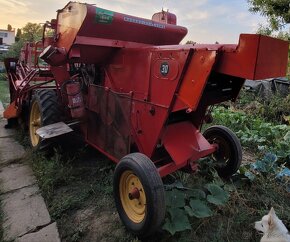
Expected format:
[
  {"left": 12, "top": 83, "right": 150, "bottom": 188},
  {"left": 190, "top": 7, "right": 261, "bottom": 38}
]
[{"left": 44, "top": 2, "right": 187, "bottom": 64}]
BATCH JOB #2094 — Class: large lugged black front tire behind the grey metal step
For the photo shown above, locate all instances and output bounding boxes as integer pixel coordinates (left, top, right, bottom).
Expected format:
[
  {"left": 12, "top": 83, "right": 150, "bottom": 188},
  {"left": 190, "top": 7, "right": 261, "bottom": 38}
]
[{"left": 29, "top": 89, "right": 62, "bottom": 150}]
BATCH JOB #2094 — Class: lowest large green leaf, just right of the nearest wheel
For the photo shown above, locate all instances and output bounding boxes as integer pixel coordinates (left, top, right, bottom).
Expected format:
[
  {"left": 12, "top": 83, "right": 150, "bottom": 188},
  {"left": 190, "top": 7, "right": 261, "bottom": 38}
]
[{"left": 163, "top": 208, "right": 191, "bottom": 235}]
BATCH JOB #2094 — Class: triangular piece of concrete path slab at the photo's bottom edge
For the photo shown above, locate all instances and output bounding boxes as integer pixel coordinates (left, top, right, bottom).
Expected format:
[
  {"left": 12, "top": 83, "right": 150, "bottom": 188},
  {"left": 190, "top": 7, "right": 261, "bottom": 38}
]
[{"left": 15, "top": 222, "right": 60, "bottom": 242}]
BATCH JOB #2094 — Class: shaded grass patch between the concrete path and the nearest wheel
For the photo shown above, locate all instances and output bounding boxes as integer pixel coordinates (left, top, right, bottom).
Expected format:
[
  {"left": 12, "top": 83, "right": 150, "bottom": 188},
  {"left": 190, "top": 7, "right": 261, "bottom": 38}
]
[{"left": 28, "top": 143, "right": 134, "bottom": 242}]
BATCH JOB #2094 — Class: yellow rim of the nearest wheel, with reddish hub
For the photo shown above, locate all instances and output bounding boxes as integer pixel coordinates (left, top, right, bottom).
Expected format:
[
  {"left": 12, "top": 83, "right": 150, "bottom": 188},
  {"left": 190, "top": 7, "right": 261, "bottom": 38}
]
[{"left": 119, "top": 170, "right": 146, "bottom": 223}]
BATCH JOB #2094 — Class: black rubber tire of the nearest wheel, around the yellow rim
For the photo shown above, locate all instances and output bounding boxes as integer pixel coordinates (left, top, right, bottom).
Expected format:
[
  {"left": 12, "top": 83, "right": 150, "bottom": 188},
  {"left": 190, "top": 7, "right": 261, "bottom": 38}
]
[{"left": 113, "top": 153, "right": 166, "bottom": 238}]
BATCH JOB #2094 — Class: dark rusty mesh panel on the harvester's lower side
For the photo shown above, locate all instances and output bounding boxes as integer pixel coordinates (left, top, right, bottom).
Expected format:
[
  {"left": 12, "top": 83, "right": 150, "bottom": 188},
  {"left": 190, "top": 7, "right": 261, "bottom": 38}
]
[{"left": 87, "top": 85, "right": 132, "bottom": 159}]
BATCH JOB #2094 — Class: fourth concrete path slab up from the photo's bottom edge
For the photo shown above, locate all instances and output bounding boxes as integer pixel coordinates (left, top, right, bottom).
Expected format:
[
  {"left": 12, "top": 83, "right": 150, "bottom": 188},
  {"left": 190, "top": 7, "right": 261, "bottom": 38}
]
[{"left": 0, "top": 138, "right": 25, "bottom": 165}]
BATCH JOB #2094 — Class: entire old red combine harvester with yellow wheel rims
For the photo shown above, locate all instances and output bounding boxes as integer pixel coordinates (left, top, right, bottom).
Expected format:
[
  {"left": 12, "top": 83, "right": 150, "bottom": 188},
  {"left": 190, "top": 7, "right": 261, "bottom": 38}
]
[{"left": 4, "top": 2, "right": 288, "bottom": 236}]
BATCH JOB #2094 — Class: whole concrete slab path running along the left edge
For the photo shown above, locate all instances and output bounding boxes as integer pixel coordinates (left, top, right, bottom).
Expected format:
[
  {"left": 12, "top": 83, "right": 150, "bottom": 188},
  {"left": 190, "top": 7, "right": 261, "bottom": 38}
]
[{"left": 0, "top": 101, "right": 60, "bottom": 242}]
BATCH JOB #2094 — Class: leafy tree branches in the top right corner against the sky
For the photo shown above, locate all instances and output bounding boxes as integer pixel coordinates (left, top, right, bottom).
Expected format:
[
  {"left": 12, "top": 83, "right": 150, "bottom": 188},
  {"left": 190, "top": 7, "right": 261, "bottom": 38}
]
[{"left": 247, "top": 0, "right": 290, "bottom": 30}]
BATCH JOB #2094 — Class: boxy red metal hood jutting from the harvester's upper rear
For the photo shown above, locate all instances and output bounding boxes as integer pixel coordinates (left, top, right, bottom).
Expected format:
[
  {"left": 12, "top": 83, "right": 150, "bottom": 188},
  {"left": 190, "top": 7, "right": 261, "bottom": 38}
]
[{"left": 215, "top": 34, "right": 289, "bottom": 80}]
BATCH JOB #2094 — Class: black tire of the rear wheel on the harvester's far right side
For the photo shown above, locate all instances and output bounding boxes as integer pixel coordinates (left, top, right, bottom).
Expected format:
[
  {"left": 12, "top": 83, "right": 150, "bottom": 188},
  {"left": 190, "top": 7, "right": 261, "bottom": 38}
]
[{"left": 203, "top": 125, "right": 242, "bottom": 178}]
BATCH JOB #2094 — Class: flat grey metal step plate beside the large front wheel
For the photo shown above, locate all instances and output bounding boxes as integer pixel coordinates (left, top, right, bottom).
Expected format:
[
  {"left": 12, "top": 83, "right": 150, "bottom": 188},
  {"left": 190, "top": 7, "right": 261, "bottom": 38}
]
[{"left": 36, "top": 122, "right": 73, "bottom": 139}]
